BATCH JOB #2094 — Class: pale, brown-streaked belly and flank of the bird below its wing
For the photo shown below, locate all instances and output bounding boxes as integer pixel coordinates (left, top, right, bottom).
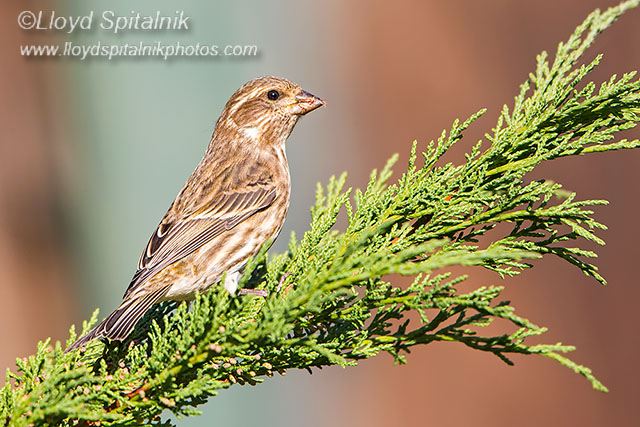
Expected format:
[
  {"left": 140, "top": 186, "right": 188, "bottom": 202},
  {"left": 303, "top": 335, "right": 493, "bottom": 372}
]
[{"left": 160, "top": 182, "right": 289, "bottom": 300}]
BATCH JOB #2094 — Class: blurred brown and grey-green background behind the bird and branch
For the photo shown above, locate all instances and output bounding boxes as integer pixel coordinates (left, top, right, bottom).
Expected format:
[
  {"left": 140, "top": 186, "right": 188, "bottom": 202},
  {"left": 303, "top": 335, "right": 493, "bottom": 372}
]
[{"left": 0, "top": 0, "right": 640, "bottom": 427}]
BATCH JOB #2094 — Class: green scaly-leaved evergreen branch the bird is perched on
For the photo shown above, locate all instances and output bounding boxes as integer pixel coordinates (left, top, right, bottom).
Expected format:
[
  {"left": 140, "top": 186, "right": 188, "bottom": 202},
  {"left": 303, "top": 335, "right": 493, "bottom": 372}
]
[{"left": 0, "top": 0, "right": 640, "bottom": 426}]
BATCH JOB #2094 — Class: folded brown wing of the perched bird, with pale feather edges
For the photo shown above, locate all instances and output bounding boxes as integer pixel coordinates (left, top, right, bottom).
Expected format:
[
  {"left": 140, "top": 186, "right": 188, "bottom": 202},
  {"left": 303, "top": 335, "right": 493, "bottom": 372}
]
[{"left": 124, "top": 180, "right": 277, "bottom": 298}]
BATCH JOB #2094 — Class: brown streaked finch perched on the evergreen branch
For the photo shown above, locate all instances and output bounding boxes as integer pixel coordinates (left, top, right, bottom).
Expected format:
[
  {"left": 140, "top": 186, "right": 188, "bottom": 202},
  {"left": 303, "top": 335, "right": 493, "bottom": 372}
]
[{"left": 65, "top": 76, "right": 326, "bottom": 352}]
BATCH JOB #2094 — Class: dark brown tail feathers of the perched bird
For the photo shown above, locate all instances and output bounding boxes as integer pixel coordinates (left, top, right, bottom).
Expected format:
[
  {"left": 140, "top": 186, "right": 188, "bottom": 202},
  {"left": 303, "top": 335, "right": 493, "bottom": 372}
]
[{"left": 64, "top": 288, "right": 167, "bottom": 353}]
